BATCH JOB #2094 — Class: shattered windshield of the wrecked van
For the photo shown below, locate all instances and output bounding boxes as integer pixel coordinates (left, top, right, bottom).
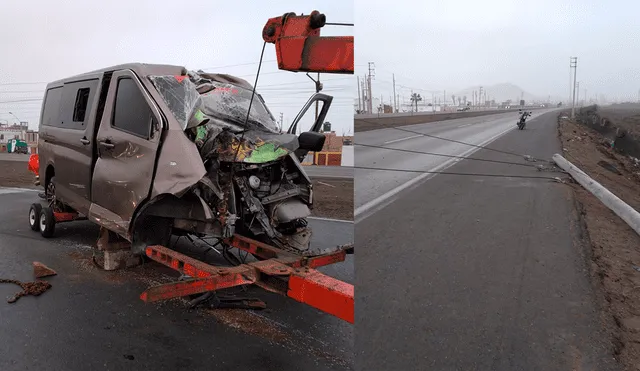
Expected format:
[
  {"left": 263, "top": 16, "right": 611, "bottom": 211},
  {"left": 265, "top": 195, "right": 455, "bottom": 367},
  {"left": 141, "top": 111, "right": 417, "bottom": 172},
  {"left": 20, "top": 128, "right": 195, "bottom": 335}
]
[{"left": 149, "top": 74, "right": 280, "bottom": 133}]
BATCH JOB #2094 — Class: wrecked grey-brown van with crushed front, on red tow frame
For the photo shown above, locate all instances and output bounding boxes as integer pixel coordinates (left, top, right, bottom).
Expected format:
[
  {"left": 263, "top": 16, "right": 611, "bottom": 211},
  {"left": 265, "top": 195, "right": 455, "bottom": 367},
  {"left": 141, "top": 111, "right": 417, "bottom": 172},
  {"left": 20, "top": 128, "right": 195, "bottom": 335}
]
[{"left": 38, "top": 64, "right": 332, "bottom": 256}]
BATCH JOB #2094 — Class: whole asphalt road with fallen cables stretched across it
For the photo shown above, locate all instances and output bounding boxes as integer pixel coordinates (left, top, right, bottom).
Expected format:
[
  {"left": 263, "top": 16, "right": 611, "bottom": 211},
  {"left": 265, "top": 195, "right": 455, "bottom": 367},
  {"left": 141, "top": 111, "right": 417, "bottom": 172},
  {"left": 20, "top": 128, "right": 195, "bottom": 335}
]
[{"left": 355, "top": 113, "right": 617, "bottom": 371}]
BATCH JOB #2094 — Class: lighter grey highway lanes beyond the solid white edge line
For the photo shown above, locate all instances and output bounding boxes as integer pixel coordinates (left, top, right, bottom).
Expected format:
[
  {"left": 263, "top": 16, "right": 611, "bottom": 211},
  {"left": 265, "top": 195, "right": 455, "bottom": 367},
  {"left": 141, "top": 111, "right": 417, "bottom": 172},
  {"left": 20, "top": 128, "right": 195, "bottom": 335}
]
[{"left": 355, "top": 110, "right": 549, "bottom": 220}]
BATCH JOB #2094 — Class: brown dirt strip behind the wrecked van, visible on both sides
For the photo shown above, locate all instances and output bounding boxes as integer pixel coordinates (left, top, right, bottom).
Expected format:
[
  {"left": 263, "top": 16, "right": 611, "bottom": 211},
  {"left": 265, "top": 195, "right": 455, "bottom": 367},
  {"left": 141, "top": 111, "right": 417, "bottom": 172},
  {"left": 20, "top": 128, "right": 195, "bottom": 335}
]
[{"left": 0, "top": 160, "right": 353, "bottom": 220}]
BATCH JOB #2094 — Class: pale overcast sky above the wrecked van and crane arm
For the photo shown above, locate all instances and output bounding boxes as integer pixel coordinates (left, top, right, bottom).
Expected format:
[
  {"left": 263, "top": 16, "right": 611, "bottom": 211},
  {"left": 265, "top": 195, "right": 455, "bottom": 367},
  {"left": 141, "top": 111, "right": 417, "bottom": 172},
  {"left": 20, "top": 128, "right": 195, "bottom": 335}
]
[{"left": 0, "top": 0, "right": 356, "bottom": 134}]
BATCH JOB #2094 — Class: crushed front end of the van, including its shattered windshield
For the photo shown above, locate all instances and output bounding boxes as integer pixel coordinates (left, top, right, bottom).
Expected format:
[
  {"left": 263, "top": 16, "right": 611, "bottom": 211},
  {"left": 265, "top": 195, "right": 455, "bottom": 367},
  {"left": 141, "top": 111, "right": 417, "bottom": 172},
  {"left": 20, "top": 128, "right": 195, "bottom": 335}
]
[{"left": 151, "top": 71, "right": 333, "bottom": 256}]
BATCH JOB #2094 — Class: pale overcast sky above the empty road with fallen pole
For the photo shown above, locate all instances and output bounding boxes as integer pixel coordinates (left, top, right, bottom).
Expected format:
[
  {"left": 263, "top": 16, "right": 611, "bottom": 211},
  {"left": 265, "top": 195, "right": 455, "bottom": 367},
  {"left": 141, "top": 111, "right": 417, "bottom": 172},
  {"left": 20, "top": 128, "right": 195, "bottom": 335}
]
[{"left": 355, "top": 0, "right": 640, "bottom": 107}]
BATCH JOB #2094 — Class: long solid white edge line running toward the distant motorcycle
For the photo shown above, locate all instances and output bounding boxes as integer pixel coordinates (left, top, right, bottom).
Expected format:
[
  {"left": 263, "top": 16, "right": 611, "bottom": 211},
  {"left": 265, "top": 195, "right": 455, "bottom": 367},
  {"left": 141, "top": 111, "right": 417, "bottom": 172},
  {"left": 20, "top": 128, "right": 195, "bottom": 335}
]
[{"left": 353, "top": 127, "right": 515, "bottom": 224}]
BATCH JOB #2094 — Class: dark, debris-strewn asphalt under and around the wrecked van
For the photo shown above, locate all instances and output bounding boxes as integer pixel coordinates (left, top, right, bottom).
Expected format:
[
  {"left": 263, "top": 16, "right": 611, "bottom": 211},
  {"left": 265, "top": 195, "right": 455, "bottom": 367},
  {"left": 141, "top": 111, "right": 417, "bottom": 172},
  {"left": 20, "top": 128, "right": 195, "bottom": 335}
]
[{"left": 0, "top": 189, "right": 354, "bottom": 371}]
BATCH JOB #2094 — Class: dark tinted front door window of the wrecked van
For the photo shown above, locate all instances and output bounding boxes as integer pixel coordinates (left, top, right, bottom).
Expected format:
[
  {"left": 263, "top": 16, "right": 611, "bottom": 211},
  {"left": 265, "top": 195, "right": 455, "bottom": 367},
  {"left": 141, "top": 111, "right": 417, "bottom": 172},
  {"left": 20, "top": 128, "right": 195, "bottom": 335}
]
[{"left": 111, "top": 78, "right": 153, "bottom": 139}]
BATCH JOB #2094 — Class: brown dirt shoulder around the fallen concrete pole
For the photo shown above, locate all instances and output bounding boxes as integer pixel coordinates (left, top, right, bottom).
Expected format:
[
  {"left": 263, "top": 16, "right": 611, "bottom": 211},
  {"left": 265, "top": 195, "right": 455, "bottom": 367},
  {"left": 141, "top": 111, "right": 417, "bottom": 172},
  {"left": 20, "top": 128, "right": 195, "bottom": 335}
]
[{"left": 558, "top": 115, "right": 640, "bottom": 370}]
